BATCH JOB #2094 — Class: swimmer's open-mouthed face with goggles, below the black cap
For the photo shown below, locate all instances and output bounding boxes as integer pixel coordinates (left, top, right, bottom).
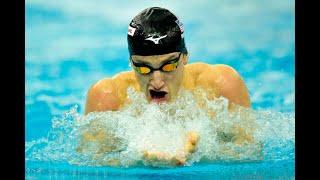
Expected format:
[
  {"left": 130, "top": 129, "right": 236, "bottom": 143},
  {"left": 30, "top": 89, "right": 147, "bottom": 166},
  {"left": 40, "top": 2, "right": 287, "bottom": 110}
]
[{"left": 131, "top": 52, "right": 188, "bottom": 103}]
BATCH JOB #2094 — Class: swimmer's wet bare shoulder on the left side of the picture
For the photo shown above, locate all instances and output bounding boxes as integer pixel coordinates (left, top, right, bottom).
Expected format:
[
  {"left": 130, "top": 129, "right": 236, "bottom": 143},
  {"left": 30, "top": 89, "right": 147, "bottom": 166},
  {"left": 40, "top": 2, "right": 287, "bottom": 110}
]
[{"left": 85, "top": 71, "right": 138, "bottom": 114}]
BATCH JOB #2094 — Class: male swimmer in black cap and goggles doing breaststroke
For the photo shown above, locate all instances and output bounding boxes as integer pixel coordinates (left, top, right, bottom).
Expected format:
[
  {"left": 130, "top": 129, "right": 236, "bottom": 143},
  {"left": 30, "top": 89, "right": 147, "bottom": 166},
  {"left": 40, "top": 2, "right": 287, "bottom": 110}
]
[{"left": 80, "top": 7, "right": 260, "bottom": 165}]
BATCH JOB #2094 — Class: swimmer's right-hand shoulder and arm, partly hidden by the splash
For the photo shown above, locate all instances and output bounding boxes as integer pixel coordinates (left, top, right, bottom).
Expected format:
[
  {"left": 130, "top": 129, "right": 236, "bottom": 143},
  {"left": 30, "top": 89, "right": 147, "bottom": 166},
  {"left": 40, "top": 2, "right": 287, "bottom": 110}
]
[{"left": 197, "top": 64, "right": 255, "bottom": 144}]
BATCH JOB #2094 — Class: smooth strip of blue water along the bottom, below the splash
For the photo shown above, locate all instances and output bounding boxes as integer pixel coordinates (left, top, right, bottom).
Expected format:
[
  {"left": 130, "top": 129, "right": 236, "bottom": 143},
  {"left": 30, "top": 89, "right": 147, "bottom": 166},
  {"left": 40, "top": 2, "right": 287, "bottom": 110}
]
[{"left": 26, "top": 161, "right": 294, "bottom": 179}]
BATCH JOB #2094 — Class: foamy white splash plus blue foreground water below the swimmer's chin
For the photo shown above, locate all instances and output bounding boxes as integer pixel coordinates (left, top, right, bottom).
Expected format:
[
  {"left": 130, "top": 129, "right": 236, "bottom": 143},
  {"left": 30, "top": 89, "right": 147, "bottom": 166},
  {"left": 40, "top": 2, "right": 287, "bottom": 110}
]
[{"left": 26, "top": 88, "right": 295, "bottom": 178}]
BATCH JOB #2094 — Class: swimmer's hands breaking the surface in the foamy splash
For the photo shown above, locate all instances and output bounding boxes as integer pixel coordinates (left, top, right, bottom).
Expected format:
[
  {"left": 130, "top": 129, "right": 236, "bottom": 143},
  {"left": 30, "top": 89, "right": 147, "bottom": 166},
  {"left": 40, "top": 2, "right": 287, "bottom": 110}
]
[{"left": 142, "top": 132, "right": 199, "bottom": 166}]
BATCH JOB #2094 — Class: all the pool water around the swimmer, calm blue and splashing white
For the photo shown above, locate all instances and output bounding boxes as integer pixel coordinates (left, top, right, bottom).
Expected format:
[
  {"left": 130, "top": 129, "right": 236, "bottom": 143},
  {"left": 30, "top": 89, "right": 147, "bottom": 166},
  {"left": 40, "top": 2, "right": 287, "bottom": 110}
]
[{"left": 25, "top": 0, "right": 295, "bottom": 179}]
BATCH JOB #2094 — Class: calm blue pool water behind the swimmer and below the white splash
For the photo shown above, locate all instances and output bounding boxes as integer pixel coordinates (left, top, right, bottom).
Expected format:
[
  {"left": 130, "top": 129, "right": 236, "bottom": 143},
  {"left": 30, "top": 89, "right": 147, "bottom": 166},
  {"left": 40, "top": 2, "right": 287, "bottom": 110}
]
[{"left": 25, "top": 0, "right": 295, "bottom": 179}]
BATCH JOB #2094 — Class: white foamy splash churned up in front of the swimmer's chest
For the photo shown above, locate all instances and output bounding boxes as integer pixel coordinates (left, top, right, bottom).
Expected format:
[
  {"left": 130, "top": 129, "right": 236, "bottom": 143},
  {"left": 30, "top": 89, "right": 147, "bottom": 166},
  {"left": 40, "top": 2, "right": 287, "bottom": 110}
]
[{"left": 25, "top": 88, "right": 295, "bottom": 167}]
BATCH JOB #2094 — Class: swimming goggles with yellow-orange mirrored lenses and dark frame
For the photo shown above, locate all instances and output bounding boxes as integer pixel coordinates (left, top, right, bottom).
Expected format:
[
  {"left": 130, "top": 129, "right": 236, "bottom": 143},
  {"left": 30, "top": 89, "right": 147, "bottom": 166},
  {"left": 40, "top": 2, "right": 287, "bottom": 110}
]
[{"left": 131, "top": 53, "right": 181, "bottom": 74}]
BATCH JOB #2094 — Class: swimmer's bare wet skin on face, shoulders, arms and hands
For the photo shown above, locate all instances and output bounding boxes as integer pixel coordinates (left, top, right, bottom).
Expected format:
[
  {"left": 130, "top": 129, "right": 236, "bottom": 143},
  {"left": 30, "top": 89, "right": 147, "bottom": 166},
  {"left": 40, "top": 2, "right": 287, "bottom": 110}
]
[{"left": 84, "top": 52, "right": 253, "bottom": 165}]
